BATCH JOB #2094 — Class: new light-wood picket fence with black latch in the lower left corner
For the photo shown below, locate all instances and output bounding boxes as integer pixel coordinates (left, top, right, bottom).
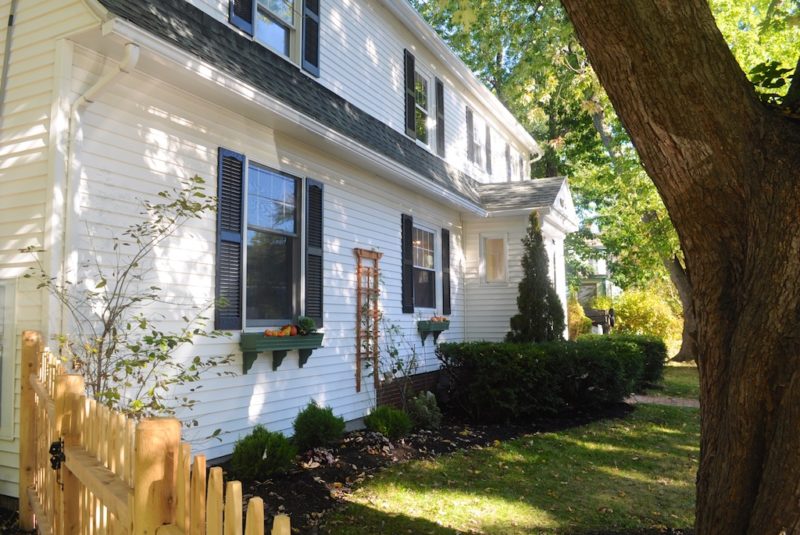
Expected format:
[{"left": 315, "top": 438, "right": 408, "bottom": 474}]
[{"left": 20, "top": 331, "right": 291, "bottom": 535}]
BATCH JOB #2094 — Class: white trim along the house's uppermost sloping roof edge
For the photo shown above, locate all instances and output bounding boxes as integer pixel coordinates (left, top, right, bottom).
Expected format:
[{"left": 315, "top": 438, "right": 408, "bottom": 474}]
[{"left": 379, "top": 0, "right": 542, "bottom": 160}]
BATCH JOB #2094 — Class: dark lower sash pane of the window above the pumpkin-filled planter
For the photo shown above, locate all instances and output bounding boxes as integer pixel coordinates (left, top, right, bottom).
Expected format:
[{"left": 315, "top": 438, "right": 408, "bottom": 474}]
[{"left": 247, "top": 230, "right": 295, "bottom": 323}]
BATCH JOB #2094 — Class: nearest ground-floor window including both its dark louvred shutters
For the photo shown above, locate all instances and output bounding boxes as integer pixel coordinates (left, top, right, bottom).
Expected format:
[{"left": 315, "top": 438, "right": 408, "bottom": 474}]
[{"left": 214, "top": 148, "right": 323, "bottom": 330}]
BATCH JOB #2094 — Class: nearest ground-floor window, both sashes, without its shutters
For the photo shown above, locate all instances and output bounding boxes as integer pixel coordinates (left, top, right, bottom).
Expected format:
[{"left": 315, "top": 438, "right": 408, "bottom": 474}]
[{"left": 245, "top": 164, "right": 300, "bottom": 326}]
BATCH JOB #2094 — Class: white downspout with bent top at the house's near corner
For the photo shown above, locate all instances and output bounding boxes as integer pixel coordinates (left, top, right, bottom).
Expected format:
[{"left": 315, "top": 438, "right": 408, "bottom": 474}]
[{"left": 60, "top": 43, "right": 139, "bottom": 333}]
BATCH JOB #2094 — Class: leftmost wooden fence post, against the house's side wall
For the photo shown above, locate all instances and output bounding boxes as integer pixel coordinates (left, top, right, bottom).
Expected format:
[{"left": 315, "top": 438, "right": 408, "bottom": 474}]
[{"left": 19, "top": 331, "right": 42, "bottom": 530}]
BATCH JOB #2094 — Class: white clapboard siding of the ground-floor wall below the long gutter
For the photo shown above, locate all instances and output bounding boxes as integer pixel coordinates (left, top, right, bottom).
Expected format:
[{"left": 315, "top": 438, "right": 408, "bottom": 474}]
[{"left": 74, "top": 49, "right": 465, "bottom": 457}]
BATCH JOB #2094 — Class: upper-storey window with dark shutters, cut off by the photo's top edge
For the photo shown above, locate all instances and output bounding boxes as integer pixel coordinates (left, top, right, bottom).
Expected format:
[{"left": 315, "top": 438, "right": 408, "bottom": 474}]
[{"left": 229, "top": 0, "right": 320, "bottom": 76}]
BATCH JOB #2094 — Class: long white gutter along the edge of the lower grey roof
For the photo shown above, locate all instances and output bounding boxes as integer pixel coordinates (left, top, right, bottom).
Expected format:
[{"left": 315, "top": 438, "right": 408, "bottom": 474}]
[{"left": 103, "top": 18, "right": 486, "bottom": 217}]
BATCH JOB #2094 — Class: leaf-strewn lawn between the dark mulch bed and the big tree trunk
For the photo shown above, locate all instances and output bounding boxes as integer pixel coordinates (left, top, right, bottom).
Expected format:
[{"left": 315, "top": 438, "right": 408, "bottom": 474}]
[{"left": 327, "top": 405, "right": 700, "bottom": 535}]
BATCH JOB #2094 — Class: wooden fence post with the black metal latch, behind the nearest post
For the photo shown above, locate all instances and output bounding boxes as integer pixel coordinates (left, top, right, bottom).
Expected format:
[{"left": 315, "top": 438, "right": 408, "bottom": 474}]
[{"left": 53, "top": 374, "right": 84, "bottom": 533}]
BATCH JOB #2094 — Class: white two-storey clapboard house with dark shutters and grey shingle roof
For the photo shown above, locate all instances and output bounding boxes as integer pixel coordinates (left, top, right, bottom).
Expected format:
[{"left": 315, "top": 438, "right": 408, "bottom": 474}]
[{"left": 0, "top": 0, "right": 577, "bottom": 496}]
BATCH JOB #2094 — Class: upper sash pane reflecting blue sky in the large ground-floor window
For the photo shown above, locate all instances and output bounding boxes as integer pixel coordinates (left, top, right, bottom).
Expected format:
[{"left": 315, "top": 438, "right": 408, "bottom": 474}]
[{"left": 247, "top": 166, "right": 297, "bottom": 234}]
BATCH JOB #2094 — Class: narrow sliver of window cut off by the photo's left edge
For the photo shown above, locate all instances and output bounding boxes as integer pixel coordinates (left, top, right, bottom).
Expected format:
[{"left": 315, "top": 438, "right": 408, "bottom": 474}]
[{"left": 0, "top": 280, "right": 16, "bottom": 438}]
